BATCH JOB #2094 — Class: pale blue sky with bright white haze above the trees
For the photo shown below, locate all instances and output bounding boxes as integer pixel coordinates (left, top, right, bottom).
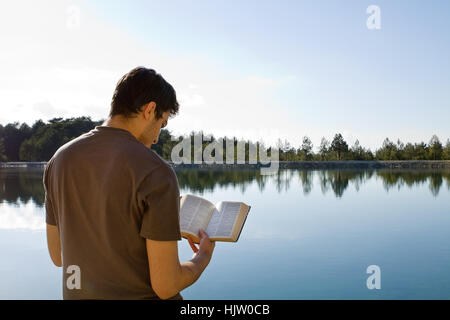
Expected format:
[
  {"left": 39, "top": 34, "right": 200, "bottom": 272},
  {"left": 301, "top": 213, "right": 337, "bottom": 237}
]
[{"left": 0, "top": 0, "right": 450, "bottom": 150}]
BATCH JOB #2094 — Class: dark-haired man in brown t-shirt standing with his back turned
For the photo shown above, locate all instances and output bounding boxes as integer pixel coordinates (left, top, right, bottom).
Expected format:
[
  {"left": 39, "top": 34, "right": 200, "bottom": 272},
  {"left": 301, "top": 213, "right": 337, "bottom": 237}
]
[{"left": 43, "top": 67, "right": 215, "bottom": 299}]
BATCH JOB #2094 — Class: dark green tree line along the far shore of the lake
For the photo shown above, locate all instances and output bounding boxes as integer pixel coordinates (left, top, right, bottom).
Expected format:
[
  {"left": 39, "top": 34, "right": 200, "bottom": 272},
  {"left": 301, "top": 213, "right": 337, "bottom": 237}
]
[{"left": 0, "top": 117, "right": 450, "bottom": 162}]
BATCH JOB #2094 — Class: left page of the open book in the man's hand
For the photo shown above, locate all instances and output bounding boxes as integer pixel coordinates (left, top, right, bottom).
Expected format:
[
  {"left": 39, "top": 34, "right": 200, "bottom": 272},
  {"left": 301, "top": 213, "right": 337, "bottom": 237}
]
[{"left": 180, "top": 194, "right": 215, "bottom": 236}]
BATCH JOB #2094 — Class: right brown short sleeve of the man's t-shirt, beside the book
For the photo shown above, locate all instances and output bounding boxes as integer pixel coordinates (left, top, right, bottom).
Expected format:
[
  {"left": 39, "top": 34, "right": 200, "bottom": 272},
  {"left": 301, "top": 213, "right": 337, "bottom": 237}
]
[{"left": 137, "top": 164, "right": 181, "bottom": 241}]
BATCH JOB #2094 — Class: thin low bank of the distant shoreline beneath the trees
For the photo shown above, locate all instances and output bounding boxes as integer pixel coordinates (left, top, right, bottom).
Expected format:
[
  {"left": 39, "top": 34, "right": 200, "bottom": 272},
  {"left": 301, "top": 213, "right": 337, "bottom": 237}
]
[{"left": 0, "top": 160, "right": 450, "bottom": 169}]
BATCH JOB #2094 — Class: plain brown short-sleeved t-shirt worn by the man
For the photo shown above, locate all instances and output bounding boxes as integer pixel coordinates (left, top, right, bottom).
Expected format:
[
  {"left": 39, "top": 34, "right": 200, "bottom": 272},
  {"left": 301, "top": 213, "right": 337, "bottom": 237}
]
[{"left": 44, "top": 126, "right": 182, "bottom": 299}]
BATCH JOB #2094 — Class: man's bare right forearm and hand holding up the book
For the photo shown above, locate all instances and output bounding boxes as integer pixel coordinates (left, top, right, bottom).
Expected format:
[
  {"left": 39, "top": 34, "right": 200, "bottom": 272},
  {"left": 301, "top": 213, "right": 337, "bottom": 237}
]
[{"left": 146, "top": 232, "right": 215, "bottom": 299}]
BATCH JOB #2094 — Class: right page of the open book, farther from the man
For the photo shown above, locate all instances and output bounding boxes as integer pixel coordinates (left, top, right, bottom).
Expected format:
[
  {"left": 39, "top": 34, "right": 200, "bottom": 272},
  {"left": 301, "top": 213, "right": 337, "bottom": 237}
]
[{"left": 206, "top": 201, "right": 241, "bottom": 238}]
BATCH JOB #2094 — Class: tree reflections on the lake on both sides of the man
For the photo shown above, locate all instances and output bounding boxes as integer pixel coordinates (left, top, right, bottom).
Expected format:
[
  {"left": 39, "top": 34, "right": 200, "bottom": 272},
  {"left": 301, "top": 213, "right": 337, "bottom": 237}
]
[{"left": 0, "top": 168, "right": 450, "bottom": 207}]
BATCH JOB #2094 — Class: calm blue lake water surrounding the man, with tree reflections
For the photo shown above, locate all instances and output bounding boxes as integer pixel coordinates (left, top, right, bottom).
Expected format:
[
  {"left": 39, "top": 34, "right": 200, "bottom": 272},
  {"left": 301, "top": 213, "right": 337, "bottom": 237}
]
[{"left": 0, "top": 169, "right": 450, "bottom": 299}]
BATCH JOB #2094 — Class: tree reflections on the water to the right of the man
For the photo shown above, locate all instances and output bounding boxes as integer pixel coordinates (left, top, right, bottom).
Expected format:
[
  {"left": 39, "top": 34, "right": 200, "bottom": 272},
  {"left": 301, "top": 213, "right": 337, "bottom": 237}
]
[{"left": 177, "top": 169, "right": 450, "bottom": 198}]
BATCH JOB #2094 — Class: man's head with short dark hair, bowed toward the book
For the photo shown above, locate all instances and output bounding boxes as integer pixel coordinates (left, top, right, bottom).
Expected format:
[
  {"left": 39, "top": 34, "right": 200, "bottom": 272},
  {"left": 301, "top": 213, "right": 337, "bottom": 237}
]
[{"left": 109, "top": 67, "right": 179, "bottom": 147}]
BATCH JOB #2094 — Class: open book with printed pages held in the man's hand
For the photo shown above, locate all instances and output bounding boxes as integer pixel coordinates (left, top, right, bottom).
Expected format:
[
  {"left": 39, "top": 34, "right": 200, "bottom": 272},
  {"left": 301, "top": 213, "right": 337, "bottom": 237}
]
[{"left": 180, "top": 194, "right": 250, "bottom": 243}]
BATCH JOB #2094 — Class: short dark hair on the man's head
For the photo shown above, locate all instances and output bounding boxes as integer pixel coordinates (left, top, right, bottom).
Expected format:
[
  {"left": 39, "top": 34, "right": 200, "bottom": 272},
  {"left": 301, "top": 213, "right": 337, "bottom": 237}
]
[{"left": 109, "top": 67, "right": 179, "bottom": 119}]
